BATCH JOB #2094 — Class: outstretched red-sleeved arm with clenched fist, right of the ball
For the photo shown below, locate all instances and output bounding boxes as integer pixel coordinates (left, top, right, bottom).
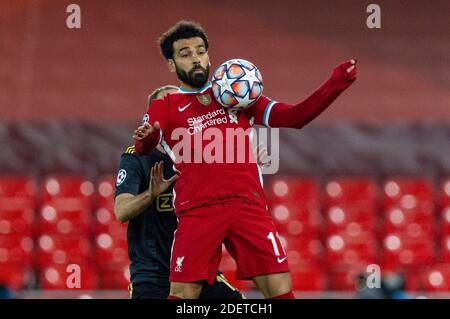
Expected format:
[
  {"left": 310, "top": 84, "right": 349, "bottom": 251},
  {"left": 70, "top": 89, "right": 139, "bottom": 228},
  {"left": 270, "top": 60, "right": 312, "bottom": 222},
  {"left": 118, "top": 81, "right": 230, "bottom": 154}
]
[{"left": 251, "top": 60, "right": 356, "bottom": 128}]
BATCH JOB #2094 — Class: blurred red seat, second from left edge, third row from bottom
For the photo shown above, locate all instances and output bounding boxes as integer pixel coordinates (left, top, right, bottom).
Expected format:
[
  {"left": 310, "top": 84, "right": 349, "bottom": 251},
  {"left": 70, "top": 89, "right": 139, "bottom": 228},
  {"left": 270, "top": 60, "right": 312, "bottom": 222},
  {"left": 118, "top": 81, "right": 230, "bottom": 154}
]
[{"left": 38, "top": 204, "right": 92, "bottom": 237}]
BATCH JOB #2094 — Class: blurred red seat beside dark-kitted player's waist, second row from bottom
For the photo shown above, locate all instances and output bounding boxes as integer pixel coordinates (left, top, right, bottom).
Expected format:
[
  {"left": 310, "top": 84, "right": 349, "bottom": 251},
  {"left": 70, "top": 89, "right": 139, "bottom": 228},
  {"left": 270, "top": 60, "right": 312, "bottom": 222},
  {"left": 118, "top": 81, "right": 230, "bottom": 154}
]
[{"left": 95, "top": 233, "right": 129, "bottom": 267}]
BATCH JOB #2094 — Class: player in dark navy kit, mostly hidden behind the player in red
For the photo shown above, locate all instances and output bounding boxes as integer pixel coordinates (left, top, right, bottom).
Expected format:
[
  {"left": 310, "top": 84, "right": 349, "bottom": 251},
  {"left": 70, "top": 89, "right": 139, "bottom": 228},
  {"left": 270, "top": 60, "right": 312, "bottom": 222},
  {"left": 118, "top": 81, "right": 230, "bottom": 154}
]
[{"left": 114, "top": 85, "right": 242, "bottom": 299}]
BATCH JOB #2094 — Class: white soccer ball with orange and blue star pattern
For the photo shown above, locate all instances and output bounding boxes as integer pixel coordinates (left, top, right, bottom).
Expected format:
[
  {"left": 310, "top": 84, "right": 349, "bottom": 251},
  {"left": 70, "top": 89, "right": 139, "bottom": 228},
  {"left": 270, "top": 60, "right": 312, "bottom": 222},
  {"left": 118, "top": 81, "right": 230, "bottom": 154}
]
[{"left": 212, "top": 59, "right": 263, "bottom": 109}]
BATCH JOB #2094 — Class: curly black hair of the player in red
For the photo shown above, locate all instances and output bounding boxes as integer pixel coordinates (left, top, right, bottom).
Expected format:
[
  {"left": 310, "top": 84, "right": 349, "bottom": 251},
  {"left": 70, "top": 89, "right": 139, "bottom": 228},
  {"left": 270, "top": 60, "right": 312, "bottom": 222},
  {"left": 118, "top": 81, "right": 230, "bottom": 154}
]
[{"left": 158, "top": 20, "right": 208, "bottom": 59}]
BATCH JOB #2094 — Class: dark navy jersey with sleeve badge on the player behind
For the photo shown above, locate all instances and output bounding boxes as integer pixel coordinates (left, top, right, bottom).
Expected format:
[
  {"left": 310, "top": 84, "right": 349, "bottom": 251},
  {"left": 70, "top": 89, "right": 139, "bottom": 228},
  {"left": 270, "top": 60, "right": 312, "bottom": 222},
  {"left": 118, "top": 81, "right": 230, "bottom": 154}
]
[{"left": 115, "top": 147, "right": 177, "bottom": 285}]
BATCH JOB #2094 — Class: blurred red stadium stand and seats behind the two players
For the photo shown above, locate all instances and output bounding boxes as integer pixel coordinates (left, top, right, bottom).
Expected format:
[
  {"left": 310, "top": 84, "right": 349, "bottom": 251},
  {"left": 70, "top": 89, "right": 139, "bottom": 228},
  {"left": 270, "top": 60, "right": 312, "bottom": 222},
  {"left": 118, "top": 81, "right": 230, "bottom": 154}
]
[{"left": 0, "top": 0, "right": 450, "bottom": 298}]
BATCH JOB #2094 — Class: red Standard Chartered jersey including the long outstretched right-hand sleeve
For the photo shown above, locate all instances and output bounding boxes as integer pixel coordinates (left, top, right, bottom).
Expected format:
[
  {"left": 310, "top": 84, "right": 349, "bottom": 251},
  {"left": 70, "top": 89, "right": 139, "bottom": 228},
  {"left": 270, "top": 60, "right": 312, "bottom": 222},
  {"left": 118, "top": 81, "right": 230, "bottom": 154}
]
[{"left": 135, "top": 60, "right": 356, "bottom": 213}]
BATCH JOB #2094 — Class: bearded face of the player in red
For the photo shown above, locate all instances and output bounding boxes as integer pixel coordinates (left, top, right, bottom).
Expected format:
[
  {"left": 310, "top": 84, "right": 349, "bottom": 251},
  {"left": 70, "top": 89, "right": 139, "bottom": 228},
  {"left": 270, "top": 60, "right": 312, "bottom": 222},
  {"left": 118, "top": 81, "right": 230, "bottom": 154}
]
[{"left": 169, "top": 37, "right": 210, "bottom": 89}]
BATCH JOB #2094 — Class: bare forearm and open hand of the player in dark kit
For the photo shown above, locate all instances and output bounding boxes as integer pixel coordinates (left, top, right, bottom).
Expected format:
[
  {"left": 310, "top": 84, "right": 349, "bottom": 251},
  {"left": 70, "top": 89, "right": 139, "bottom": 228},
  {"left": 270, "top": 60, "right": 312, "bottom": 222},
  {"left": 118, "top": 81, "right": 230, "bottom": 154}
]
[{"left": 114, "top": 162, "right": 178, "bottom": 222}]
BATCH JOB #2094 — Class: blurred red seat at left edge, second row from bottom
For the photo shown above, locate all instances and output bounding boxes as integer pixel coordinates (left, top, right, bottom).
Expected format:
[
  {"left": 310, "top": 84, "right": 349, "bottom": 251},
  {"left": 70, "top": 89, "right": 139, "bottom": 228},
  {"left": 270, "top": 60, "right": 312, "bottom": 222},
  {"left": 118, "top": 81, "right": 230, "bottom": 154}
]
[{"left": 0, "top": 235, "right": 33, "bottom": 266}]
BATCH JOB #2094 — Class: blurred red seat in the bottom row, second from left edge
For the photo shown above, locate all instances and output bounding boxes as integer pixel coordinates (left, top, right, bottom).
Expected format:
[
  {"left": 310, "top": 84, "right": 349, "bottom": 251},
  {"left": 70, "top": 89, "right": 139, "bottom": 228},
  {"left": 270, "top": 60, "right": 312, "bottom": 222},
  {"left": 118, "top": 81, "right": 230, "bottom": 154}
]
[{"left": 39, "top": 264, "right": 98, "bottom": 290}]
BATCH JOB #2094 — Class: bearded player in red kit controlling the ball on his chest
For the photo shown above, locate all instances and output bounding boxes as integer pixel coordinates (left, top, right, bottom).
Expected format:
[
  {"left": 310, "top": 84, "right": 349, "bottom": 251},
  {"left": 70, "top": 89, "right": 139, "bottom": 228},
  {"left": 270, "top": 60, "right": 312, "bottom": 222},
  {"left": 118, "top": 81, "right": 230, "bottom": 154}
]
[{"left": 133, "top": 21, "right": 356, "bottom": 299}]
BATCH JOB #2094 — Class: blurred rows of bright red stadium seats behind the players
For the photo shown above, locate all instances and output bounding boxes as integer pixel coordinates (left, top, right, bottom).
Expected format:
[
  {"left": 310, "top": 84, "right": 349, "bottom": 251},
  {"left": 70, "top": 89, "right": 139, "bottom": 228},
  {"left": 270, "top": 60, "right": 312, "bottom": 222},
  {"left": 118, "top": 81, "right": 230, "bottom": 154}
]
[{"left": 0, "top": 175, "right": 450, "bottom": 292}]
